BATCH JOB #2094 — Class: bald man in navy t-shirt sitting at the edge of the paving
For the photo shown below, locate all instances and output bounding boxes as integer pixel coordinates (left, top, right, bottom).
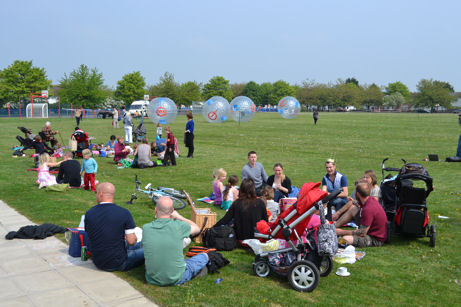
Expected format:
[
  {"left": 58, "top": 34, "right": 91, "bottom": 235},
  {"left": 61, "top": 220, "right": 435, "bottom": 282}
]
[{"left": 85, "top": 182, "right": 144, "bottom": 272}]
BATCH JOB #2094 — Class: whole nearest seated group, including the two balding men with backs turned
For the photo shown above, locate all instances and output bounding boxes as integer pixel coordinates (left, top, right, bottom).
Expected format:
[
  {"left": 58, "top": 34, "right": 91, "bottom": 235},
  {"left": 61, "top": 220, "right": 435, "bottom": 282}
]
[{"left": 85, "top": 152, "right": 387, "bottom": 286}]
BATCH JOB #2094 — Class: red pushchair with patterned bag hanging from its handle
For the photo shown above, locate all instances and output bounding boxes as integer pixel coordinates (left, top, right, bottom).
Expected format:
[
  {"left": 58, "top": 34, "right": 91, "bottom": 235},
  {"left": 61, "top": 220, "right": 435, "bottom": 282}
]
[{"left": 253, "top": 182, "right": 341, "bottom": 292}]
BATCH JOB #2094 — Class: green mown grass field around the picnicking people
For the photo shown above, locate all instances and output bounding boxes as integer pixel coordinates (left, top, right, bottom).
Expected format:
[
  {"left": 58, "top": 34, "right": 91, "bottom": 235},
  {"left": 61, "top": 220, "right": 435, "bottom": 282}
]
[{"left": 0, "top": 113, "right": 461, "bottom": 306}]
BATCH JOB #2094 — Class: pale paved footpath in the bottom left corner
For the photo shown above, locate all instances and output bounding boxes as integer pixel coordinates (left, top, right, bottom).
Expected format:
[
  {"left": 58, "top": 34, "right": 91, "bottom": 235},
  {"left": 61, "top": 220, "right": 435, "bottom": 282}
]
[{"left": 0, "top": 200, "right": 156, "bottom": 307}]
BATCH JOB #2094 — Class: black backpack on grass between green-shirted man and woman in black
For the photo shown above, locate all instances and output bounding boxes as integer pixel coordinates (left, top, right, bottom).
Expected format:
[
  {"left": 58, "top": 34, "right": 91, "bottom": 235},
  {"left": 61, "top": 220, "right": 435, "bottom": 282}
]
[{"left": 203, "top": 225, "right": 237, "bottom": 251}]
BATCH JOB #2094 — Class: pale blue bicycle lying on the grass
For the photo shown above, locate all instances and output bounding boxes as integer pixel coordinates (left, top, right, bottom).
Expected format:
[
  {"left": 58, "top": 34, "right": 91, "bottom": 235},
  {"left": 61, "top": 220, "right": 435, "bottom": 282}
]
[{"left": 126, "top": 175, "right": 186, "bottom": 210}]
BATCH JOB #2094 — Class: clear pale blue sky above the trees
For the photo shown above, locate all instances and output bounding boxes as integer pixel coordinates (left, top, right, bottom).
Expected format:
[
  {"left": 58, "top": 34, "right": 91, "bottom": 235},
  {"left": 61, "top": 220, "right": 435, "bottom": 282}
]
[{"left": 0, "top": 0, "right": 461, "bottom": 91}]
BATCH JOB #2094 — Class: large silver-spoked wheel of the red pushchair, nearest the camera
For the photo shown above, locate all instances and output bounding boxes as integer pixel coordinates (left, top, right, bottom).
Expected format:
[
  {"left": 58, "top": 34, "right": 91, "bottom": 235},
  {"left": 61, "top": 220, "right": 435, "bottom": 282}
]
[{"left": 288, "top": 260, "right": 320, "bottom": 292}]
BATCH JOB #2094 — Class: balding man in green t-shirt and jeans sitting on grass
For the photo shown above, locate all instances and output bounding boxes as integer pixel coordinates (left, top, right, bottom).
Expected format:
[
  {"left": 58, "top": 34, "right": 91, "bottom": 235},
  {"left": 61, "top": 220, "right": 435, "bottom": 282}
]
[{"left": 142, "top": 196, "right": 208, "bottom": 286}]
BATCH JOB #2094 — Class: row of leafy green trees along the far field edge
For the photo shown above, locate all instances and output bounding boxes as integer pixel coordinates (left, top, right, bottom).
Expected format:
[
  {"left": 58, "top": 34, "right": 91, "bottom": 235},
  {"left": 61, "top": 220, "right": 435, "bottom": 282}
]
[{"left": 0, "top": 61, "right": 457, "bottom": 109}]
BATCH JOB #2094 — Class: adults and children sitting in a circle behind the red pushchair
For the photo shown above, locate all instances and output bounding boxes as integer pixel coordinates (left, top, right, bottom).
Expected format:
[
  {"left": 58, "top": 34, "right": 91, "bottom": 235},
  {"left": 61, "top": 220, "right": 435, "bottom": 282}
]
[{"left": 213, "top": 151, "right": 387, "bottom": 247}]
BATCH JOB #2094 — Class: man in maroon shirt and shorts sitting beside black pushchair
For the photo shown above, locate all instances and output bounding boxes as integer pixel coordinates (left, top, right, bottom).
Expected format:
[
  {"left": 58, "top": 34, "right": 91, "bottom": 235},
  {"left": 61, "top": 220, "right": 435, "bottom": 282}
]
[{"left": 335, "top": 181, "right": 387, "bottom": 247}]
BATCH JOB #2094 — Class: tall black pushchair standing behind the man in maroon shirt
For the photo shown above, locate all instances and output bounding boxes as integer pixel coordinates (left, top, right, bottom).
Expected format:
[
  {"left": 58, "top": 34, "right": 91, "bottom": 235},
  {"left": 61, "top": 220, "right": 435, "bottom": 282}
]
[{"left": 381, "top": 158, "right": 436, "bottom": 247}]
